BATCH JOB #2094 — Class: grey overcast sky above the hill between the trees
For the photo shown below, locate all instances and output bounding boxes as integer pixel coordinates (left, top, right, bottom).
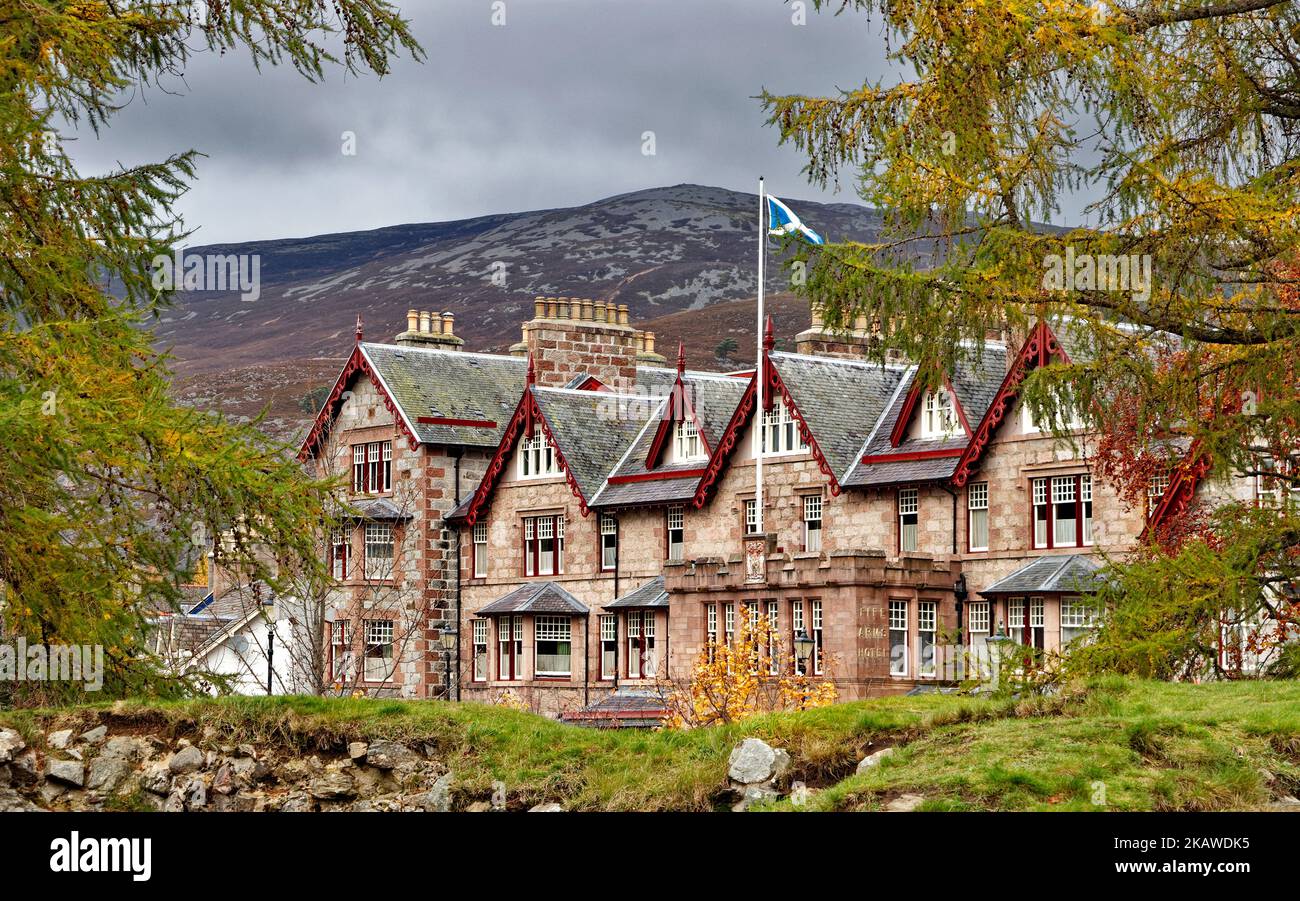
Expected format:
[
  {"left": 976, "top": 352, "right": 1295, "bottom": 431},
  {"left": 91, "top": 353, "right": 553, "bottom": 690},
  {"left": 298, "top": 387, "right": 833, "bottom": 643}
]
[{"left": 74, "top": 0, "right": 1081, "bottom": 243}]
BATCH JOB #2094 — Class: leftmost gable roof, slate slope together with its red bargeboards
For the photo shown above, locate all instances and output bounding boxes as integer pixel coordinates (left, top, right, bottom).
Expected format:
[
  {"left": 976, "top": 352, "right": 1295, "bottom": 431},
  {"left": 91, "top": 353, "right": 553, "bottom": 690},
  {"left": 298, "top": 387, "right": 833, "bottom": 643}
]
[{"left": 298, "top": 341, "right": 525, "bottom": 460}]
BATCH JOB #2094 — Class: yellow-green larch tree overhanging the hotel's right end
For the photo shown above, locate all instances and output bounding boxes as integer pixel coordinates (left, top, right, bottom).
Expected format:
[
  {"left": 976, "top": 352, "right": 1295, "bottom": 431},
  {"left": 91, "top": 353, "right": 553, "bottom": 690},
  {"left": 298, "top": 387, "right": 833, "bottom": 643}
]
[{"left": 762, "top": 0, "right": 1300, "bottom": 675}]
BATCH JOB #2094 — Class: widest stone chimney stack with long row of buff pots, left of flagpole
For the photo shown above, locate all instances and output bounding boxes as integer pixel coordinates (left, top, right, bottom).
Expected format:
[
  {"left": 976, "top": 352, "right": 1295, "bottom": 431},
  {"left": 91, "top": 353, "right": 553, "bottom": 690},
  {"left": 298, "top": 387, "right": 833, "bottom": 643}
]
[{"left": 510, "top": 296, "right": 666, "bottom": 389}]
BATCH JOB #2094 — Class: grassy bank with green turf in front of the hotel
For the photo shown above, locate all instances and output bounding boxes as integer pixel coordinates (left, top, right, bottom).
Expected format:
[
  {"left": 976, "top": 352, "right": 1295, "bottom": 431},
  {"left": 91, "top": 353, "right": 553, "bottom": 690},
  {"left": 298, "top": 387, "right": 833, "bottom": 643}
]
[{"left": 0, "top": 679, "right": 1300, "bottom": 810}]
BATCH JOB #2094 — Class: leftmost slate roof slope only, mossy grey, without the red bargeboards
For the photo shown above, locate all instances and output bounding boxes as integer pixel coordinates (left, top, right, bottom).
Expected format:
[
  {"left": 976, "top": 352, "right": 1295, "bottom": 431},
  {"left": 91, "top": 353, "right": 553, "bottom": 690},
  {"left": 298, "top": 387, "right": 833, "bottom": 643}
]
[{"left": 361, "top": 342, "right": 528, "bottom": 447}]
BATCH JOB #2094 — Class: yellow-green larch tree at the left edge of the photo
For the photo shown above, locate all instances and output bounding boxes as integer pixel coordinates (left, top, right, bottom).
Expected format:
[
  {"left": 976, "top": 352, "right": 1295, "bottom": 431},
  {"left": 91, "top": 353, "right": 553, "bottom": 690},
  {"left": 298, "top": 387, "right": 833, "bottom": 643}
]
[{"left": 0, "top": 0, "right": 421, "bottom": 703}]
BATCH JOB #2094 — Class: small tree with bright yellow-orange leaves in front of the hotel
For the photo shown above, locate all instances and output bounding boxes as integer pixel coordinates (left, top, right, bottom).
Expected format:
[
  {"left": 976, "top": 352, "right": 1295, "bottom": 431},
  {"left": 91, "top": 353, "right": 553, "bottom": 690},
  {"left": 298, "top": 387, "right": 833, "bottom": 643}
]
[{"left": 660, "top": 614, "right": 839, "bottom": 729}]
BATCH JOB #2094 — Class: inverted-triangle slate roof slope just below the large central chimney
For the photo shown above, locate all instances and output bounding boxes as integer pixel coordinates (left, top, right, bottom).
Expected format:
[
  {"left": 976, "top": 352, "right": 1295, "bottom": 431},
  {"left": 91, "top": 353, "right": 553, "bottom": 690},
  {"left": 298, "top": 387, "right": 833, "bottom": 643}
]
[{"left": 532, "top": 387, "right": 654, "bottom": 501}]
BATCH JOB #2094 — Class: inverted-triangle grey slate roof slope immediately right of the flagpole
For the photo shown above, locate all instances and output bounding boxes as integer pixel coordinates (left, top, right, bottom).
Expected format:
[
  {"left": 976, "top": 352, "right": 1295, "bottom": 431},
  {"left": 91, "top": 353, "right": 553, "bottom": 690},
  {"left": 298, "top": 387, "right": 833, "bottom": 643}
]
[{"left": 770, "top": 352, "right": 905, "bottom": 481}]
